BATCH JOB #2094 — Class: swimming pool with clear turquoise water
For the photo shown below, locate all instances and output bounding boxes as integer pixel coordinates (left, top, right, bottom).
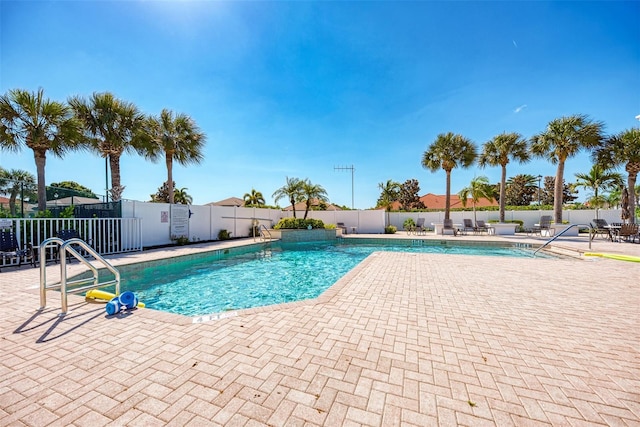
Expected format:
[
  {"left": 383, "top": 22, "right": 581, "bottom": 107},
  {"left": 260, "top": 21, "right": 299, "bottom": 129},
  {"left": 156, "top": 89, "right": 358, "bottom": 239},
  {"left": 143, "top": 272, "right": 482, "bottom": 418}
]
[{"left": 102, "top": 239, "right": 544, "bottom": 317}]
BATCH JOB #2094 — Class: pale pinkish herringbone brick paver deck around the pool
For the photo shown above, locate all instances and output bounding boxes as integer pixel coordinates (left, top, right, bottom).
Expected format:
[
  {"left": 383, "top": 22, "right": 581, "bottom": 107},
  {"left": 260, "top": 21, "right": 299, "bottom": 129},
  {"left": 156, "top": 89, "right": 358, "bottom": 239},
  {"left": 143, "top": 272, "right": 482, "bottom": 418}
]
[{"left": 0, "top": 235, "right": 640, "bottom": 427}]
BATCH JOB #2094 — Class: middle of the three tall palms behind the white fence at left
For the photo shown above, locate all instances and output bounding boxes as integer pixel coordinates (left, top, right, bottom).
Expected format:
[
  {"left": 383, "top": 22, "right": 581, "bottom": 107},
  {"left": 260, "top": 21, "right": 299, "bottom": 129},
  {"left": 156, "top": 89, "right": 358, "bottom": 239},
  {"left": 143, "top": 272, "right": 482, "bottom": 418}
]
[{"left": 69, "top": 92, "right": 146, "bottom": 201}]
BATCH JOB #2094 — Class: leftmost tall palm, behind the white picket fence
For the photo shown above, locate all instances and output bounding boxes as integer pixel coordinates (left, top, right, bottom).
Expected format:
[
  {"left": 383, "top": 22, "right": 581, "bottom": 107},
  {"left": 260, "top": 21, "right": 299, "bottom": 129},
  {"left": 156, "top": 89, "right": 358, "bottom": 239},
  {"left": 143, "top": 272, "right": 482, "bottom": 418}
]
[{"left": 0, "top": 89, "right": 83, "bottom": 212}]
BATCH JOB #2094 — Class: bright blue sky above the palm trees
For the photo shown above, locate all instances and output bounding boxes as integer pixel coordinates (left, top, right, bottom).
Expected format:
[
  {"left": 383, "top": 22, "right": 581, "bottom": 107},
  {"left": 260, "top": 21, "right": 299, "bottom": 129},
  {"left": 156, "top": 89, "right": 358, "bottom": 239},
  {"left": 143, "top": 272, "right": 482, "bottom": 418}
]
[{"left": 0, "top": 0, "right": 640, "bottom": 208}]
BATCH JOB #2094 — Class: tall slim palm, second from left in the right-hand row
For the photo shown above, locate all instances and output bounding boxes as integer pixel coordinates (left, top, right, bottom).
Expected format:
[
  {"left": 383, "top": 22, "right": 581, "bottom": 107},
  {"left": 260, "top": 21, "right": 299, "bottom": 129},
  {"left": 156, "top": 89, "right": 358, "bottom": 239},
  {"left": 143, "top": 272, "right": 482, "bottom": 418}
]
[{"left": 478, "top": 133, "right": 529, "bottom": 222}]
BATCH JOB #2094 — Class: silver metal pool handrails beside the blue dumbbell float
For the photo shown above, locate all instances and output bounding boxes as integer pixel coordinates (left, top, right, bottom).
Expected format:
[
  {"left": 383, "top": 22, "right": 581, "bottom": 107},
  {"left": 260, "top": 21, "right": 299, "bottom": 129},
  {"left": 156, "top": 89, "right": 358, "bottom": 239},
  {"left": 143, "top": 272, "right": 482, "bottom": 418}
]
[{"left": 38, "top": 237, "right": 120, "bottom": 316}]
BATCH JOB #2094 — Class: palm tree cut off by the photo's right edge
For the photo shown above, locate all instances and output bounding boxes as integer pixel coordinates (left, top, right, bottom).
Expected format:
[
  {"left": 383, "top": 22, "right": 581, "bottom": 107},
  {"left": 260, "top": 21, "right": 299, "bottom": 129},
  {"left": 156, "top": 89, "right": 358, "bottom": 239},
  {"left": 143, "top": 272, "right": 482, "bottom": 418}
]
[{"left": 593, "top": 128, "right": 640, "bottom": 223}]
